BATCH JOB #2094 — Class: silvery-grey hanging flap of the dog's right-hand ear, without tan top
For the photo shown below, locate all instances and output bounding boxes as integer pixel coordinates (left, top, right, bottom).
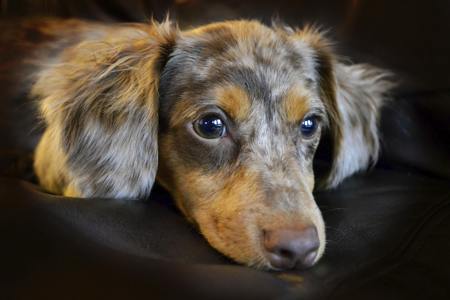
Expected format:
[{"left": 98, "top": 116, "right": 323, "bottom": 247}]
[{"left": 325, "top": 62, "right": 394, "bottom": 187}]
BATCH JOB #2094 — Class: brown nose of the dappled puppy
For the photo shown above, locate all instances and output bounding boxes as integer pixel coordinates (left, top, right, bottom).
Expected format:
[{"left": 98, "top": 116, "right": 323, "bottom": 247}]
[{"left": 264, "top": 226, "right": 319, "bottom": 269}]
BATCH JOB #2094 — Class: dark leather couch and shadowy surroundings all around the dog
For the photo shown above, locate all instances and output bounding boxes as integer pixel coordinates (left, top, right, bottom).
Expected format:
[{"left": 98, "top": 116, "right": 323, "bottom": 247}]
[{"left": 0, "top": 0, "right": 450, "bottom": 299}]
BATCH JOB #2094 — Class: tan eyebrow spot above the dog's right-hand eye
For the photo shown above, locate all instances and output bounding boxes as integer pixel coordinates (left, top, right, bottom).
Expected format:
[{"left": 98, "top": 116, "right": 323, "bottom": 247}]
[{"left": 282, "top": 85, "right": 310, "bottom": 123}]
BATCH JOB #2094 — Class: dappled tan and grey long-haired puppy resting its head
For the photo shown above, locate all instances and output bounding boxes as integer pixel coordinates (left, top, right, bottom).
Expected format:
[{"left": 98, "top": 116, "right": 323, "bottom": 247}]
[{"left": 12, "top": 20, "right": 392, "bottom": 270}]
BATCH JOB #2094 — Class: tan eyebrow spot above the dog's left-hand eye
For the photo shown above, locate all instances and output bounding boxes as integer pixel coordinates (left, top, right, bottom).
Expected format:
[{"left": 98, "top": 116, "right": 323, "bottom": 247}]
[{"left": 215, "top": 85, "right": 251, "bottom": 121}]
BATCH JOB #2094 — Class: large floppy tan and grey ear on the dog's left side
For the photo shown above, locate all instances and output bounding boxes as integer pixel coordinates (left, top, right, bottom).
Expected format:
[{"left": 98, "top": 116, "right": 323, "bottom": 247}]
[{"left": 32, "top": 22, "right": 177, "bottom": 198}]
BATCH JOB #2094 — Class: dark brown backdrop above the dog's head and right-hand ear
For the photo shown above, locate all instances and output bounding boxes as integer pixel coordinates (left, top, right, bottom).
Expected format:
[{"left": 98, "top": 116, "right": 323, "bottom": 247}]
[{"left": 1, "top": 0, "right": 450, "bottom": 92}]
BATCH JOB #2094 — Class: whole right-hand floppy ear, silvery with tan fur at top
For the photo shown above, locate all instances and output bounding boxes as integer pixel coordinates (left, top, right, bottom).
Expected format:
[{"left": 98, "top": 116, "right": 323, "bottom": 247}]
[{"left": 296, "top": 27, "right": 393, "bottom": 188}]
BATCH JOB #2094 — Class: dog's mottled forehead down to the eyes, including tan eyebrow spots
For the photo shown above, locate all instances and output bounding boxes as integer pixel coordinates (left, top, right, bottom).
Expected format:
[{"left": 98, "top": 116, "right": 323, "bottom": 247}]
[{"left": 161, "top": 21, "right": 317, "bottom": 129}]
